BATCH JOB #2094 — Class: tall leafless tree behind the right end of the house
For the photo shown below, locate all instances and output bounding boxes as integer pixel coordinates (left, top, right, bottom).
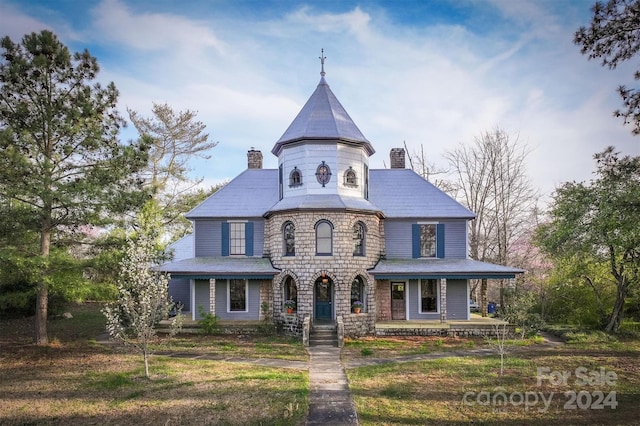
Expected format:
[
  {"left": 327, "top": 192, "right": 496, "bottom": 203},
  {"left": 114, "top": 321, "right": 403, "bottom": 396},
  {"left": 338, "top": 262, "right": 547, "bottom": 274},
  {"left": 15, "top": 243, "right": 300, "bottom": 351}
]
[{"left": 445, "top": 128, "right": 539, "bottom": 316}]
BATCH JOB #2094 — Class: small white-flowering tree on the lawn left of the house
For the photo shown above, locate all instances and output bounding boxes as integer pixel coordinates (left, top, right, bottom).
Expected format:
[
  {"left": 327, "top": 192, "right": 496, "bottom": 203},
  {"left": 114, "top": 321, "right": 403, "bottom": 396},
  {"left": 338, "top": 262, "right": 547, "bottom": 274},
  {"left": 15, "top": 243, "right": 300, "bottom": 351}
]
[{"left": 103, "top": 234, "right": 182, "bottom": 378}]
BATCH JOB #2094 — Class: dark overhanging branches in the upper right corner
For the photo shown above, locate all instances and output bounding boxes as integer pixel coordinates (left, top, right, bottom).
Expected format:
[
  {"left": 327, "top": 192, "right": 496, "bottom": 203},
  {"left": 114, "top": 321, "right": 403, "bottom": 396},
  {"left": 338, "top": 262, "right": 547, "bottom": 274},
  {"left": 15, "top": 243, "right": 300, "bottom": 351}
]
[{"left": 573, "top": 0, "right": 640, "bottom": 135}]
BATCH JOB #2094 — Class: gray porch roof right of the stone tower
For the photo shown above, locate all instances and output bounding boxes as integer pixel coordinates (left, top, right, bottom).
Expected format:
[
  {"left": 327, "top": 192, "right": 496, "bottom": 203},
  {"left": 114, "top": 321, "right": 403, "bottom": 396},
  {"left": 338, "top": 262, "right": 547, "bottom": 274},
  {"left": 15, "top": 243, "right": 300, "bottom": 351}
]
[{"left": 369, "top": 259, "right": 525, "bottom": 279}]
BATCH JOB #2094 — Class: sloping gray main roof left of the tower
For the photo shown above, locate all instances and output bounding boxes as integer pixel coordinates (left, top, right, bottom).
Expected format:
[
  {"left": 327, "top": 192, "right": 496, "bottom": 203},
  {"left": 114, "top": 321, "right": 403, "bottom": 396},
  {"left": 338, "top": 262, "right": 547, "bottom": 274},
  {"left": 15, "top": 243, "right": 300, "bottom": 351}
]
[{"left": 186, "top": 169, "right": 278, "bottom": 219}]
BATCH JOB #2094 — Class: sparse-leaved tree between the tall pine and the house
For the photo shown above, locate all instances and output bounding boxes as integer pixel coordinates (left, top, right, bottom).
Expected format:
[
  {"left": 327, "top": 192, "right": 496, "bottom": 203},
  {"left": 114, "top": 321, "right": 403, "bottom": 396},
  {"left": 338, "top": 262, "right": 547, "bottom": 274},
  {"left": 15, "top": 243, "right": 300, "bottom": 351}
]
[{"left": 127, "top": 103, "right": 218, "bottom": 238}]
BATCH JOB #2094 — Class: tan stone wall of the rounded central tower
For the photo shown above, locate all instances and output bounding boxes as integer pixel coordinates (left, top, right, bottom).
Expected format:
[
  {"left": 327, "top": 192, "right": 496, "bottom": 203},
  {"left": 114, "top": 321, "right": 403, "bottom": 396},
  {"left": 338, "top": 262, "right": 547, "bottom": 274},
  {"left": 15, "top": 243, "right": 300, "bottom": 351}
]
[{"left": 264, "top": 211, "right": 384, "bottom": 336}]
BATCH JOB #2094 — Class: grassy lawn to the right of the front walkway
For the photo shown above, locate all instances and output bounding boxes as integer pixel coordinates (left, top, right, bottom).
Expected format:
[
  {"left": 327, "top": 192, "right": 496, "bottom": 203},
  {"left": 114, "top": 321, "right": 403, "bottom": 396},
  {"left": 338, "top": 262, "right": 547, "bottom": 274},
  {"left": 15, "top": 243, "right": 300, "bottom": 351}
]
[{"left": 347, "top": 341, "right": 640, "bottom": 425}]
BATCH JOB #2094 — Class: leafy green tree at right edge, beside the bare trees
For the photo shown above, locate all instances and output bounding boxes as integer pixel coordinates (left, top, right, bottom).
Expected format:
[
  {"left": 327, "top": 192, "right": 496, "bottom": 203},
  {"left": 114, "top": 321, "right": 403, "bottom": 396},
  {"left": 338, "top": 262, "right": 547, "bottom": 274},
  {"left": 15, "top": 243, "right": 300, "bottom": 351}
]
[{"left": 536, "top": 147, "right": 640, "bottom": 332}]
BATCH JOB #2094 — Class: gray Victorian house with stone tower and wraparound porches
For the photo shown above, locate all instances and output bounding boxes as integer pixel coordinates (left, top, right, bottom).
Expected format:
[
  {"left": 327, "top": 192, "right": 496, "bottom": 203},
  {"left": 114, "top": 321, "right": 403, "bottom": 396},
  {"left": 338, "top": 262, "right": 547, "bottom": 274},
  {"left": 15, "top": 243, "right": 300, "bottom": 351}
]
[{"left": 160, "top": 60, "right": 523, "bottom": 335}]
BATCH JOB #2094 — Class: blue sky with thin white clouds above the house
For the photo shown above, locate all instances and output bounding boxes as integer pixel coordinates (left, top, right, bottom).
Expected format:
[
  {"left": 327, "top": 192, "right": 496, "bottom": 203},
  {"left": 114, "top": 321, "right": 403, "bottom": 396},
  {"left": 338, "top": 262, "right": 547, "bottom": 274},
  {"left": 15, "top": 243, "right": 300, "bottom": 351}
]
[{"left": 0, "top": 0, "right": 640, "bottom": 200}]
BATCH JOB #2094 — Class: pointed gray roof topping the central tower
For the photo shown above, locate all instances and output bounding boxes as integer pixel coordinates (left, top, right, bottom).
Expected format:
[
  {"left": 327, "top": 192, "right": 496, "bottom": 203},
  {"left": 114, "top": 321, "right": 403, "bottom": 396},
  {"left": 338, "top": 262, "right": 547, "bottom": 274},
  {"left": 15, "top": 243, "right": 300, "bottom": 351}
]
[{"left": 271, "top": 77, "right": 375, "bottom": 155}]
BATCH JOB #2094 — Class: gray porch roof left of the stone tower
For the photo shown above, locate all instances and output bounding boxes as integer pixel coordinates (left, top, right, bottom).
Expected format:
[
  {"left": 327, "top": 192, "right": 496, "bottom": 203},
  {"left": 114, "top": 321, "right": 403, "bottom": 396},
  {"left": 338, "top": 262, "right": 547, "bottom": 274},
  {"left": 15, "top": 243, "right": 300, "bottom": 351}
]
[{"left": 156, "top": 256, "right": 280, "bottom": 279}]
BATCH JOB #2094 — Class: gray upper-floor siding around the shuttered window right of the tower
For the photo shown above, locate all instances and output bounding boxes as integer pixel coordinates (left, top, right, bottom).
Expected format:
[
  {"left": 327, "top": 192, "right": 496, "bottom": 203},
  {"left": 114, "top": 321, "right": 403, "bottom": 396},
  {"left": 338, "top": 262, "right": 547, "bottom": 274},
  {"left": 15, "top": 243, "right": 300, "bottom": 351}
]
[{"left": 384, "top": 219, "right": 467, "bottom": 259}]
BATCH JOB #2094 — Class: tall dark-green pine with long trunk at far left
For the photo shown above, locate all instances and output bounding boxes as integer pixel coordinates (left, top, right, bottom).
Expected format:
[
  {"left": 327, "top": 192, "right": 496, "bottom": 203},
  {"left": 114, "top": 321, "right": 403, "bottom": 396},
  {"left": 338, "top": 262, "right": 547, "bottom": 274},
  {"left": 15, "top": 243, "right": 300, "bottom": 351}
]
[{"left": 0, "top": 30, "right": 146, "bottom": 344}]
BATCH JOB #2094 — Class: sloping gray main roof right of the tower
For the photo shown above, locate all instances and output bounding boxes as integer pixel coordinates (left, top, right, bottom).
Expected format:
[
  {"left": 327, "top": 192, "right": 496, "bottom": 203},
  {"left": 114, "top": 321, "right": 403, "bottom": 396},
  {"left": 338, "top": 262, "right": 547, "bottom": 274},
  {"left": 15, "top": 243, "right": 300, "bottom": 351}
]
[{"left": 369, "top": 169, "right": 475, "bottom": 219}]
